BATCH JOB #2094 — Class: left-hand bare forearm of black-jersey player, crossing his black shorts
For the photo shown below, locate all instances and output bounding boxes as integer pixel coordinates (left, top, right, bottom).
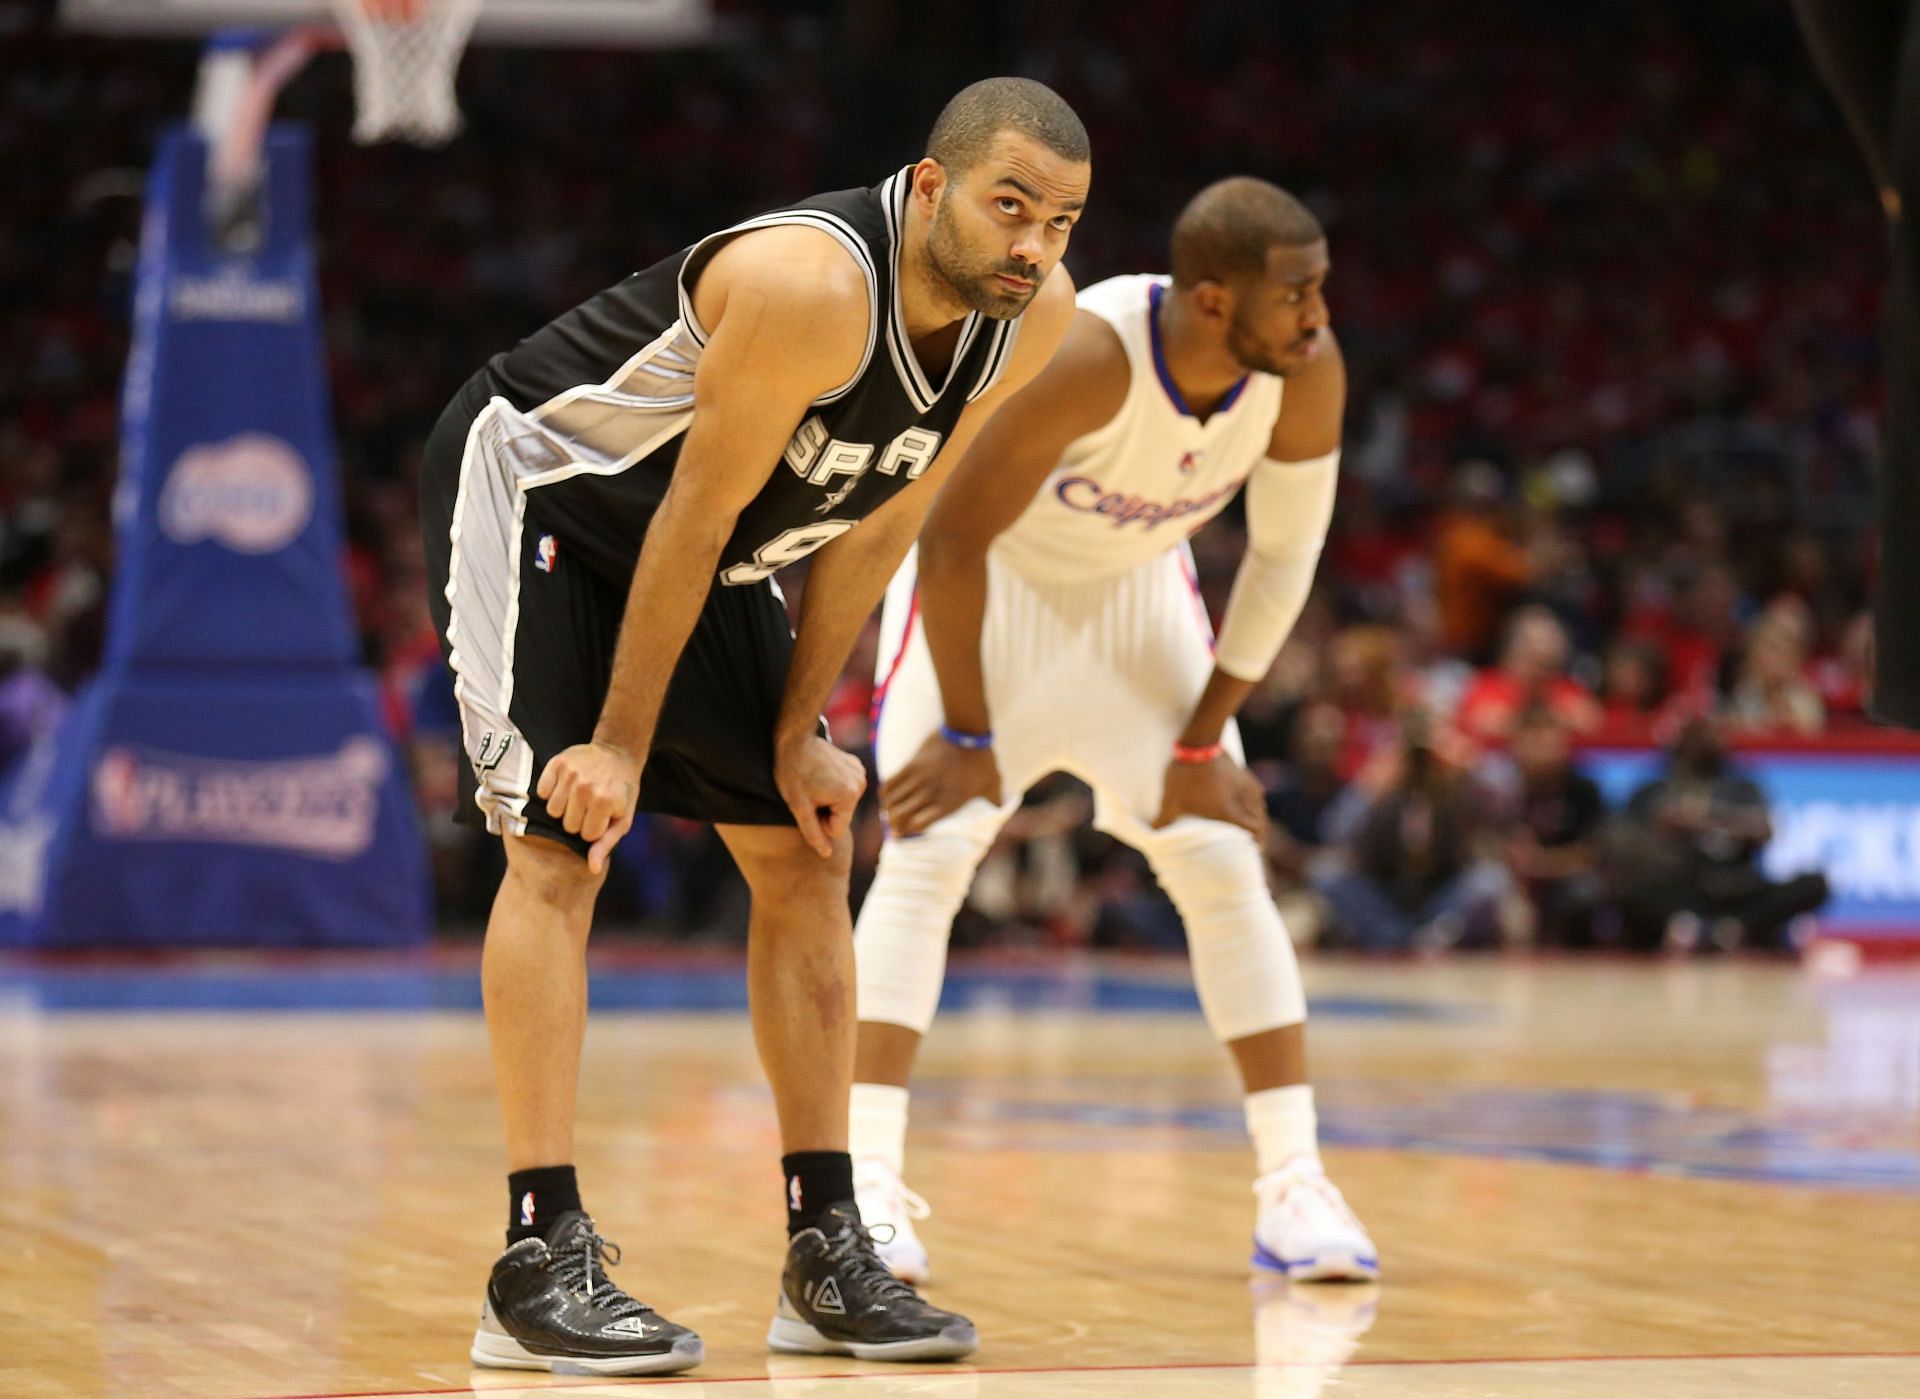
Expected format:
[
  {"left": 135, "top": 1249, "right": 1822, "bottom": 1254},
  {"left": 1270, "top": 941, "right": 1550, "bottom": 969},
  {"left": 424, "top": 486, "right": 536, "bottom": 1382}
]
[{"left": 593, "top": 489, "right": 733, "bottom": 762}]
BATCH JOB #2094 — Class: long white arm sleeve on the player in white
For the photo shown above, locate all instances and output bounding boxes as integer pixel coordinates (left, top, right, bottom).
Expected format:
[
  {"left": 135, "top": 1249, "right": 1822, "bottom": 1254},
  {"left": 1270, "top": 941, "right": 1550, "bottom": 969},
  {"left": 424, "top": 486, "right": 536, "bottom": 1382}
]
[{"left": 1213, "top": 451, "right": 1340, "bottom": 681}]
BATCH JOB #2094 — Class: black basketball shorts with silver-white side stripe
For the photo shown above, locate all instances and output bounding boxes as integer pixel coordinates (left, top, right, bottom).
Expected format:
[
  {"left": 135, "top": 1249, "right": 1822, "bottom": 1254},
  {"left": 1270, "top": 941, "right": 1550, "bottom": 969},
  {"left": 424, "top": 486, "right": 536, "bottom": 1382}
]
[{"left": 420, "top": 370, "right": 793, "bottom": 854}]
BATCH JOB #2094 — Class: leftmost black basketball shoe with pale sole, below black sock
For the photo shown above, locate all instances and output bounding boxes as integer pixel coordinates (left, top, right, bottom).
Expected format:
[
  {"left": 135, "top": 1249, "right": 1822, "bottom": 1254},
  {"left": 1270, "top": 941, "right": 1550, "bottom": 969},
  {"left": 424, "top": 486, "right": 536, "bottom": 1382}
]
[{"left": 470, "top": 1209, "right": 705, "bottom": 1374}]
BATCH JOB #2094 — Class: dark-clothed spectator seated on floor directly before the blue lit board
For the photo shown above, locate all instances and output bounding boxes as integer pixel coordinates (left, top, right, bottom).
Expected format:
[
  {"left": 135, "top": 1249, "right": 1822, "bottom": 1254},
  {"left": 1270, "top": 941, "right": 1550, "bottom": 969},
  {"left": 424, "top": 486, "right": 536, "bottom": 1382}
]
[{"left": 1615, "top": 718, "right": 1828, "bottom": 952}]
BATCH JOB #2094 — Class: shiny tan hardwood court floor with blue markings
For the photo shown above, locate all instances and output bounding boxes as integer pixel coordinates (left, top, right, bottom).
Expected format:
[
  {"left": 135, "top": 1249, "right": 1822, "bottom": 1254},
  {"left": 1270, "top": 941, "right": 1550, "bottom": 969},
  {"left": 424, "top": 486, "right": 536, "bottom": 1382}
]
[{"left": 0, "top": 961, "right": 1920, "bottom": 1399}]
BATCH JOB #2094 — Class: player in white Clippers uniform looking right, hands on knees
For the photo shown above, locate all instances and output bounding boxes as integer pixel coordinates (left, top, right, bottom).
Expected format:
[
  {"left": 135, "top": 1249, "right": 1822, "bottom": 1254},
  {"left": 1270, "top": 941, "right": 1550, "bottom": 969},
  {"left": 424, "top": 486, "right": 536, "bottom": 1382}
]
[{"left": 852, "top": 178, "right": 1379, "bottom": 1282}]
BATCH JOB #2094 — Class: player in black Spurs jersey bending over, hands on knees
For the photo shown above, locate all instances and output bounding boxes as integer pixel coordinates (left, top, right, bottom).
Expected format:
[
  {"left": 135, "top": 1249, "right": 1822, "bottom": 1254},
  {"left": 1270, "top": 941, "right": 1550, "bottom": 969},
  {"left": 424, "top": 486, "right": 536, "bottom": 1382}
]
[{"left": 422, "top": 79, "right": 1091, "bottom": 1374}]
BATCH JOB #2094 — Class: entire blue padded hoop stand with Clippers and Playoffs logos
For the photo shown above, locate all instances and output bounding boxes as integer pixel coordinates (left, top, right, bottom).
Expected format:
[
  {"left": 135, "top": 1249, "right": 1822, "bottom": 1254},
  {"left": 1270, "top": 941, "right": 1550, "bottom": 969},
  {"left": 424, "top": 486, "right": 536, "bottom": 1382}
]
[{"left": 0, "top": 129, "right": 430, "bottom": 948}]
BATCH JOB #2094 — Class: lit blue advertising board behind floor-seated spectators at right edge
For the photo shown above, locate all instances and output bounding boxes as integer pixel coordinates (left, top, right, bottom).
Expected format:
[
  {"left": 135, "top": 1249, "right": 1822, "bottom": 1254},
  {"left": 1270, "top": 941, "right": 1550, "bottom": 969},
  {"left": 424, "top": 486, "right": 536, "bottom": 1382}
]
[{"left": 1582, "top": 737, "right": 1920, "bottom": 940}]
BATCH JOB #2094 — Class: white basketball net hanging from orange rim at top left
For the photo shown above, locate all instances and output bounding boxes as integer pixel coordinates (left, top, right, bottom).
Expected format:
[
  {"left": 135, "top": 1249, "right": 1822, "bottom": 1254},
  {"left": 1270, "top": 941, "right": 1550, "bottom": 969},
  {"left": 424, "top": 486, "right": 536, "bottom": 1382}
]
[{"left": 332, "top": 0, "right": 482, "bottom": 146}]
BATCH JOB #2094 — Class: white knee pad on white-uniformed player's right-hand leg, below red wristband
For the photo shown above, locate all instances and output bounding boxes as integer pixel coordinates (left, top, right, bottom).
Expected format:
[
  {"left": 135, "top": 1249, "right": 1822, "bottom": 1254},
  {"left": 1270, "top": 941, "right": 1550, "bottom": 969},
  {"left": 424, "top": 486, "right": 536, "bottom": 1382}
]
[{"left": 1140, "top": 818, "right": 1308, "bottom": 1042}]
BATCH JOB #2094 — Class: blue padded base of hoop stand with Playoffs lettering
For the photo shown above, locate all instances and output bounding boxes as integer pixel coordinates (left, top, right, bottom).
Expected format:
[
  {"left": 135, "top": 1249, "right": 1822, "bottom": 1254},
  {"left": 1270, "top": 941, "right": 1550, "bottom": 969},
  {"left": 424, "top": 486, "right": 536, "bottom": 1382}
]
[{"left": 0, "top": 676, "right": 430, "bottom": 948}]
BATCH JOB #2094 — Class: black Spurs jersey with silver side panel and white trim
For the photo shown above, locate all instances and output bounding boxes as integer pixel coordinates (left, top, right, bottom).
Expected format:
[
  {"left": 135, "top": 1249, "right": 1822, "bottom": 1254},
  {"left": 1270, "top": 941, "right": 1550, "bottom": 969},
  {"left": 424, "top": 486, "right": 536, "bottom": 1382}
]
[{"left": 468, "top": 171, "right": 1020, "bottom": 583}]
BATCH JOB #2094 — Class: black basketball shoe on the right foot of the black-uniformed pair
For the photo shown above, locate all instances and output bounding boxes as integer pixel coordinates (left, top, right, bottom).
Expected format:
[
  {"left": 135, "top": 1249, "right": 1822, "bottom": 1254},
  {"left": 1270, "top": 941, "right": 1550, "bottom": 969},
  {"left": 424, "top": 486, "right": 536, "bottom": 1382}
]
[{"left": 766, "top": 1199, "right": 979, "bottom": 1361}]
